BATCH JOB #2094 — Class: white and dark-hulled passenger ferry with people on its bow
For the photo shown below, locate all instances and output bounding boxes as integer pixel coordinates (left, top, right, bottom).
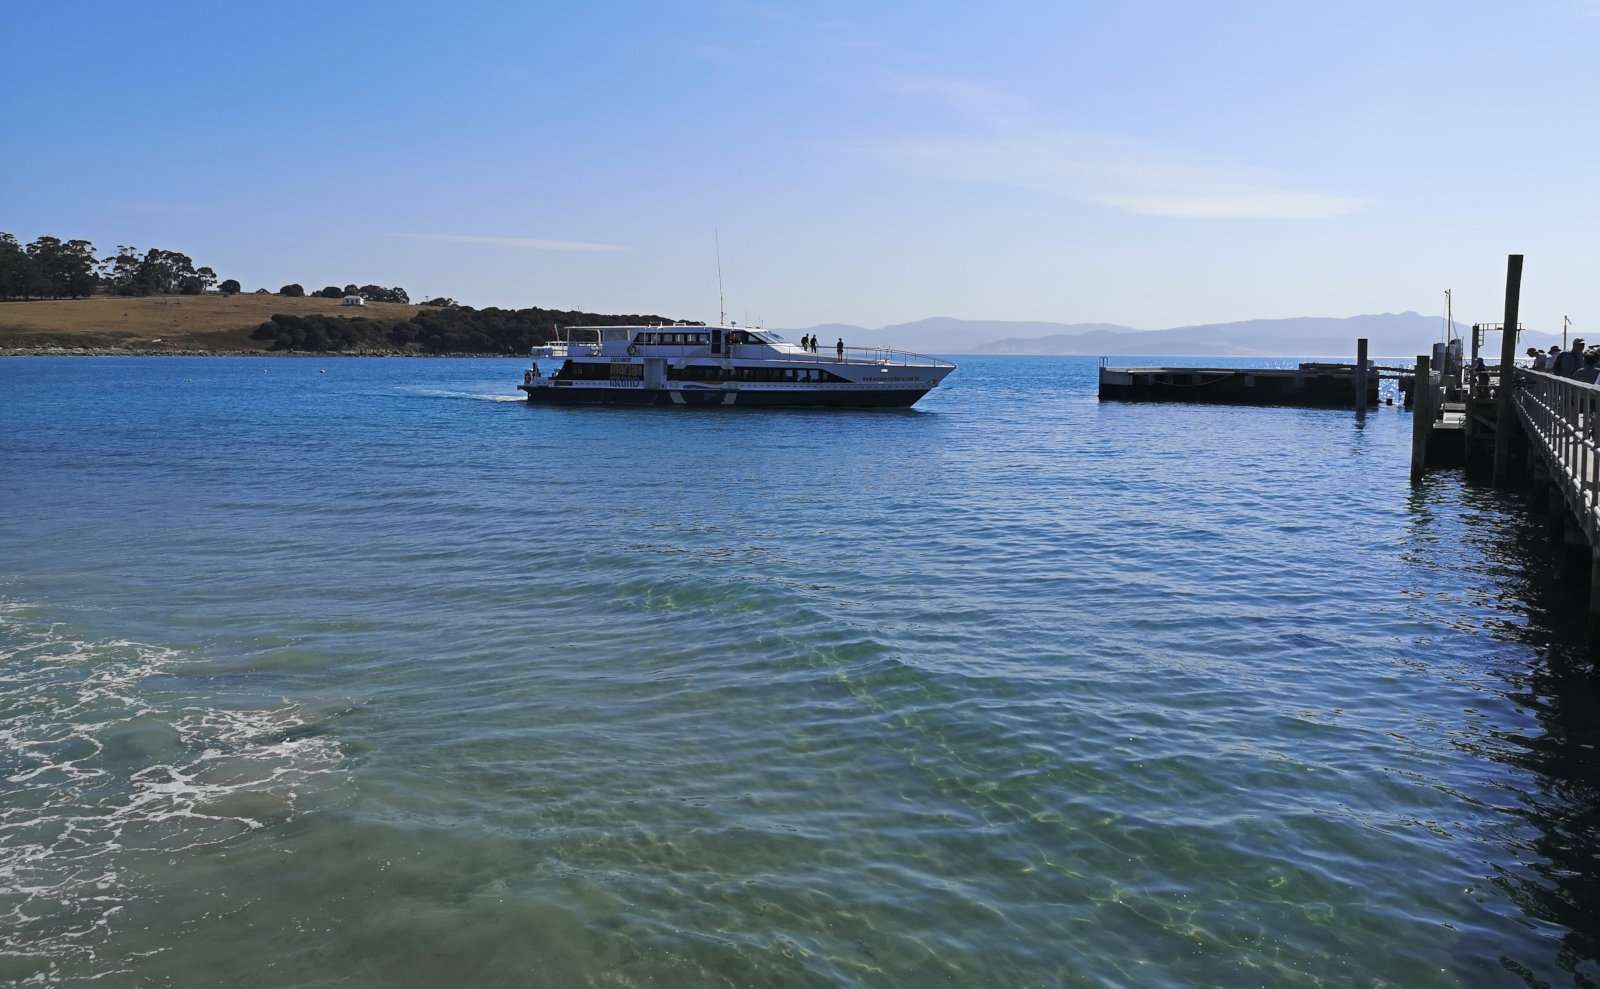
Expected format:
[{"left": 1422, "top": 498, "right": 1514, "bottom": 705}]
[{"left": 517, "top": 323, "right": 955, "bottom": 408}]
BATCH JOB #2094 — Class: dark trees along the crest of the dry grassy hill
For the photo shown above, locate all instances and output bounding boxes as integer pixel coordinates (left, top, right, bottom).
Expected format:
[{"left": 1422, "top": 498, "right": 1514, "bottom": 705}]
[{"left": 0, "top": 230, "right": 412, "bottom": 304}]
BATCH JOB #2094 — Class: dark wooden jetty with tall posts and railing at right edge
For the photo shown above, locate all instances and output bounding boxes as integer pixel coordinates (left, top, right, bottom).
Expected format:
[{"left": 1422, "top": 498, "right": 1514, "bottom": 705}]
[{"left": 1411, "top": 254, "right": 1600, "bottom": 636}]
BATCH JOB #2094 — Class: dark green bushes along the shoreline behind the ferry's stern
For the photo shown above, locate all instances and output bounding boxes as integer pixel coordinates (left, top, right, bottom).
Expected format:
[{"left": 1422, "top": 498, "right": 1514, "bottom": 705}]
[{"left": 250, "top": 310, "right": 699, "bottom": 354}]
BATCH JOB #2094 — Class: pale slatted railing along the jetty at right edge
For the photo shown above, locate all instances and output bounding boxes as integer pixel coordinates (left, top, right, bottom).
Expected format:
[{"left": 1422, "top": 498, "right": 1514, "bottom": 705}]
[{"left": 1514, "top": 368, "right": 1600, "bottom": 544}]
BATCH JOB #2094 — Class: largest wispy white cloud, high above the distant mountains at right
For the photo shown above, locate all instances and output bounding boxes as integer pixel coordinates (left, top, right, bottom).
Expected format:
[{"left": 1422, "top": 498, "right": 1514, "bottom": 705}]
[{"left": 869, "top": 78, "right": 1362, "bottom": 219}]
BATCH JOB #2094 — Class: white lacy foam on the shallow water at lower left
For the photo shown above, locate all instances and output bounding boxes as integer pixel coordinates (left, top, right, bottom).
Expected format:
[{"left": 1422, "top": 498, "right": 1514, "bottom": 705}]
[{"left": 0, "top": 600, "right": 344, "bottom": 984}]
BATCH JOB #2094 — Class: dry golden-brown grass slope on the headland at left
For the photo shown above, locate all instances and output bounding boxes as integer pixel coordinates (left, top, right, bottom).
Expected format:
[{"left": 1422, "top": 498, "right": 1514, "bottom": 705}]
[{"left": 0, "top": 294, "right": 418, "bottom": 350}]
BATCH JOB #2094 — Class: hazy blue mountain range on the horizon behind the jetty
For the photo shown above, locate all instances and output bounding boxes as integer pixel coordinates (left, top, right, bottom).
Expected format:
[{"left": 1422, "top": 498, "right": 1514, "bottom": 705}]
[{"left": 784, "top": 312, "right": 1561, "bottom": 362}]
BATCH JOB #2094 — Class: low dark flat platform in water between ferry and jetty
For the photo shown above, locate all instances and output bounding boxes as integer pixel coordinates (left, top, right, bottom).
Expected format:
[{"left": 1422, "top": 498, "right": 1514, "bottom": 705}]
[{"left": 1099, "top": 338, "right": 1388, "bottom": 408}]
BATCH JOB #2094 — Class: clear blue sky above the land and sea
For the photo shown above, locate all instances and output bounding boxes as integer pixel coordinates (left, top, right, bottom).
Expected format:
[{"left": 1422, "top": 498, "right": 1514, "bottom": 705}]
[{"left": 0, "top": 0, "right": 1600, "bottom": 334}]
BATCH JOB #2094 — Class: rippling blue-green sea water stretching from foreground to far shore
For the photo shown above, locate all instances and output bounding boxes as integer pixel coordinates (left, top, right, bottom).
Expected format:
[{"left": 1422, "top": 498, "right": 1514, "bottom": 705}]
[{"left": 0, "top": 358, "right": 1600, "bottom": 986}]
